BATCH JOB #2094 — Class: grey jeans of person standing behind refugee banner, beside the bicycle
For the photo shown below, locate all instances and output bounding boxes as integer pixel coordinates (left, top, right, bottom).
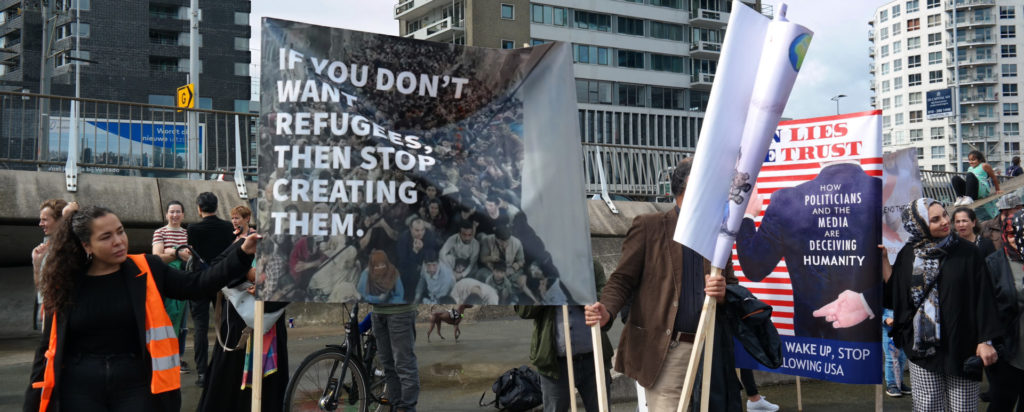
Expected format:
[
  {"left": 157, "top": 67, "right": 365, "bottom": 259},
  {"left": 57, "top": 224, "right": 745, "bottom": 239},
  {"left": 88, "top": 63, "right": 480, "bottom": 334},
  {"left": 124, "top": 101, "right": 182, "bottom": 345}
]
[{"left": 372, "top": 311, "right": 420, "bottom": 411}]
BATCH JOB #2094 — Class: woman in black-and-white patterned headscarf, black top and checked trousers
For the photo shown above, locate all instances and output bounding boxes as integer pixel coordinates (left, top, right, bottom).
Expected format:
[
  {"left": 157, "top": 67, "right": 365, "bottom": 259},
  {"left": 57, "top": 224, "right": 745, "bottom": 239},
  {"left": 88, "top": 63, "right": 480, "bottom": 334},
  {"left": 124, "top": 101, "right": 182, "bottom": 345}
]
[{"left": 882, "top": 198, "right": 1001, "bottom": 411}]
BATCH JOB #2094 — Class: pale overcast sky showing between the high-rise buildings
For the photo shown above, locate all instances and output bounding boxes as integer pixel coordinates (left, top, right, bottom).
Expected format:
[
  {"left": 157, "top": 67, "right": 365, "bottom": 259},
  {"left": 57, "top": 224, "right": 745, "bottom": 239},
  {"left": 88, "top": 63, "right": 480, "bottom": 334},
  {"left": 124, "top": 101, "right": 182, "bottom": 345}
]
[{"left": 251, "top": 0, "right": 891, "bottom": 119}]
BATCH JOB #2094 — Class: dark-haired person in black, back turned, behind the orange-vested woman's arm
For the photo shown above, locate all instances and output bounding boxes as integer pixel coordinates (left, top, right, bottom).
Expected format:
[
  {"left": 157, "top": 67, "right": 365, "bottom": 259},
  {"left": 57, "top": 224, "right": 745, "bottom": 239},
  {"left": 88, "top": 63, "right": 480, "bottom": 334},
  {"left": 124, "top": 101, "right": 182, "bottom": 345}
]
[{"left": 187, "top": 192, "right": 234, "bottom": 386}]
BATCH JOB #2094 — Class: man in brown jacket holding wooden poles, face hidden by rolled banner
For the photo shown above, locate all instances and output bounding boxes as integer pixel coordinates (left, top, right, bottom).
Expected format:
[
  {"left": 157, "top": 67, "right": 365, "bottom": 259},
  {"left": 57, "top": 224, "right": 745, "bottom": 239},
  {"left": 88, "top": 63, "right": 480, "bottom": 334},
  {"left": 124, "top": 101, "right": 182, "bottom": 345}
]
[{"left": 586, "top": 158, "right": 736, "bottom": 411}]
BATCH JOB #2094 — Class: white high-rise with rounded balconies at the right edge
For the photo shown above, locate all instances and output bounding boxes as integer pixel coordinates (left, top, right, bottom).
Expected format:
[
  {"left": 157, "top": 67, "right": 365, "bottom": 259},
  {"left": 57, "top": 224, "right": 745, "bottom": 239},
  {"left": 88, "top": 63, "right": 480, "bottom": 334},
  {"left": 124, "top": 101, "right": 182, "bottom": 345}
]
[{"left": 868, "top": 0, "right": 1024, "bottom": 173}]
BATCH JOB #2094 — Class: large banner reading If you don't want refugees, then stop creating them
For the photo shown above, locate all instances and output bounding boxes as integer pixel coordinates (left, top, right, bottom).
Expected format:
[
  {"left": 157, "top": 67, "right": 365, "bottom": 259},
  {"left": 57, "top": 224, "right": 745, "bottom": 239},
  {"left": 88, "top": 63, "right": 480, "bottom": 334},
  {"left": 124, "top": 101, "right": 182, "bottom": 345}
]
[{"left": 250, "top": 18, "right": 596, "bottom": 304}]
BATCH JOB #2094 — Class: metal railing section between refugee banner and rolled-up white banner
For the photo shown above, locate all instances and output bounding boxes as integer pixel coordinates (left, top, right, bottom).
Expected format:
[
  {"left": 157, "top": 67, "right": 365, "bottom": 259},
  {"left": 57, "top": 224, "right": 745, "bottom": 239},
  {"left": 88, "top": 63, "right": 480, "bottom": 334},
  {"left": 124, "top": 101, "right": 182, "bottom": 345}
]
[{"left": 583, "top": 143, "right": 693, "bottom": 200}]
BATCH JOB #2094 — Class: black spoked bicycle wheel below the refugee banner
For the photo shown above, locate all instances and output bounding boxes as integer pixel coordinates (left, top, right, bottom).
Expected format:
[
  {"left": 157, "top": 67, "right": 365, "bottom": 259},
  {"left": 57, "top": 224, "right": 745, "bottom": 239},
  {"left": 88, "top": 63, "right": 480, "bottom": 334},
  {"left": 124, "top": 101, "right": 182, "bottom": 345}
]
[{"left": 285, "top": 347, "right": 369, "bottom": 412}]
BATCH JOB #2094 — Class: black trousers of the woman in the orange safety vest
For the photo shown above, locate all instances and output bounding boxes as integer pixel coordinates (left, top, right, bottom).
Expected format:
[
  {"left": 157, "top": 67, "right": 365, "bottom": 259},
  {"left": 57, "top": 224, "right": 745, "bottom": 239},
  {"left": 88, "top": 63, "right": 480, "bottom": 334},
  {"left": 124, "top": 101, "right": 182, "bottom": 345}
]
[{"left": 59, "top": 354, "right": 157, "bottom": 412}]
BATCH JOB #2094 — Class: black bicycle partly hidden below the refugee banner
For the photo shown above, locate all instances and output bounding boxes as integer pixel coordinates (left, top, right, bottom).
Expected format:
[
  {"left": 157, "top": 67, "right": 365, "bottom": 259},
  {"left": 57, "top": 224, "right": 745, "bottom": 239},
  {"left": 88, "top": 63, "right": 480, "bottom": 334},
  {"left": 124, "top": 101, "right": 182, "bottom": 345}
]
[{"left": 285, "top": 303, "right": 388, "bottom": 412}]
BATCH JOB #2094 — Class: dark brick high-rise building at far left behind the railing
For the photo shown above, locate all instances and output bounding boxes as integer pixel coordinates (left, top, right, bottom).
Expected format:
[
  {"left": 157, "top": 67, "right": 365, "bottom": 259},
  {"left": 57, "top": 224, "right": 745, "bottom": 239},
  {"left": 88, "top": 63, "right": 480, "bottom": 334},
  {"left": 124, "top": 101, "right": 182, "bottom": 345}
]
[{"left": 0, "top": 0, "right": 251, "bottom": 113}]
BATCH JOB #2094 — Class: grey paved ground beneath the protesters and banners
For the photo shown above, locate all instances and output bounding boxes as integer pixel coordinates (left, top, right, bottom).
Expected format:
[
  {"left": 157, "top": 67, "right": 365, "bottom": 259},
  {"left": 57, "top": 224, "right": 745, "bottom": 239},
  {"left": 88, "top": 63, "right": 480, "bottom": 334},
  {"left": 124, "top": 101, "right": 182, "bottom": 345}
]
[{"left": 0, "top": 319, "right": 984, "bottom": 412}]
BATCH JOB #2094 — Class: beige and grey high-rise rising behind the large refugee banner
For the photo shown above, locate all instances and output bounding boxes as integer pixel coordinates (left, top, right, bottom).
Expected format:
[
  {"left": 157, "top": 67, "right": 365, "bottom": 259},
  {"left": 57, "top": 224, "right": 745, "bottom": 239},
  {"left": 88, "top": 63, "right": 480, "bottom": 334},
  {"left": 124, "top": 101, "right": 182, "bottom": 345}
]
[{"left": 394, "top": 0, "right": 761, "bottom": 154}]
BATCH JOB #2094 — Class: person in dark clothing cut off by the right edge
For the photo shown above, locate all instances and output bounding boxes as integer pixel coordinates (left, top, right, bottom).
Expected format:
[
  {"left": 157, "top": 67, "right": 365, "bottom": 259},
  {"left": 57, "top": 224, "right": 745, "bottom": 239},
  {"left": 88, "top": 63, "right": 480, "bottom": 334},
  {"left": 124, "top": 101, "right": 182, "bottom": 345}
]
[{"left": 985, "top": 211, "right": 1024, "bottom": 412}]
